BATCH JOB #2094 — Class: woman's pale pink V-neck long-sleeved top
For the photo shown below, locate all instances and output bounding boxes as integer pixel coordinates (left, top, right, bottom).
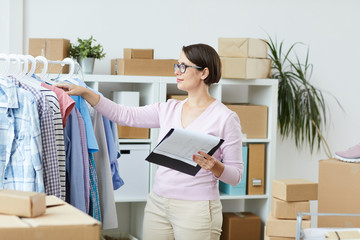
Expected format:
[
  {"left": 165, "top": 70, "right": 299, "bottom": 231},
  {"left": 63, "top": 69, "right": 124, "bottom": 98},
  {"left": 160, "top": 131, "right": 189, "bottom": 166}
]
[{"left": 94, "top": 96, "right": 243, "bottom": 200}]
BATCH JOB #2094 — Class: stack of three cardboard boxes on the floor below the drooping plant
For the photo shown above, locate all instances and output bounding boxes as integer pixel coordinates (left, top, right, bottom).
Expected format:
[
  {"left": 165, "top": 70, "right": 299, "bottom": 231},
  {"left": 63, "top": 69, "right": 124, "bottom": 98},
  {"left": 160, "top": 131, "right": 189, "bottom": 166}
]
[{"left": 265, "top": 179, "right": 318, "bottom": 240}]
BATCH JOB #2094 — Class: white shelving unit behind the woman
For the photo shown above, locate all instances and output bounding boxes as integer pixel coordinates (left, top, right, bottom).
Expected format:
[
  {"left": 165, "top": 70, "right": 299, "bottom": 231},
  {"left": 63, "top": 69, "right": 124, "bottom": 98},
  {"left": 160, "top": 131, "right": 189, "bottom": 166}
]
[{"left": 84, "top": 75, "right": 278, "bottom": 236}]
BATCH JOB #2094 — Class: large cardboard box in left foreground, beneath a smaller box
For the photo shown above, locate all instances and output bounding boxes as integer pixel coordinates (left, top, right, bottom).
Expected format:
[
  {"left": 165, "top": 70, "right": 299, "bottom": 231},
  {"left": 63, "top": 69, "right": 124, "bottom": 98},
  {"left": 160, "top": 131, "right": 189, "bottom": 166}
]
[{"left": 0, "top": 196, "right": 101, "bottom": 240}]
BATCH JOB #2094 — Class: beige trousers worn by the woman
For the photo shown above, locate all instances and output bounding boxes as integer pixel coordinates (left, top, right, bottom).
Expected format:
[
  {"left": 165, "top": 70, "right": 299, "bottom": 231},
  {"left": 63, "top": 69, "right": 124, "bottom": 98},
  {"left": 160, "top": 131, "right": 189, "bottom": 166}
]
[{"left": 143, "top": 192, "right": 222, "bottom": 240}]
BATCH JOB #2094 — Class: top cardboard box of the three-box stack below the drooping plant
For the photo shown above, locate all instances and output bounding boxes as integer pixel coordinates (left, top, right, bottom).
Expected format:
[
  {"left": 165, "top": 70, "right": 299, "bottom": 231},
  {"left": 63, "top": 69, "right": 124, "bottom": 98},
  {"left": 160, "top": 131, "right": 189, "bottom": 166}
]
[{"left": 272, "top": 179, "right": 318, "bottom": 202}]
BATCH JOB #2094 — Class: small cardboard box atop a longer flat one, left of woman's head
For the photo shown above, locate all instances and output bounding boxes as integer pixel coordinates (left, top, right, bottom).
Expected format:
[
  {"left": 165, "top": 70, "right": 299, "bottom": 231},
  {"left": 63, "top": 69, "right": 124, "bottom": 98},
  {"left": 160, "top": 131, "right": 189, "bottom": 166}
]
[{"left": 111, "top": 48, "right": 177, "bottom": 76}]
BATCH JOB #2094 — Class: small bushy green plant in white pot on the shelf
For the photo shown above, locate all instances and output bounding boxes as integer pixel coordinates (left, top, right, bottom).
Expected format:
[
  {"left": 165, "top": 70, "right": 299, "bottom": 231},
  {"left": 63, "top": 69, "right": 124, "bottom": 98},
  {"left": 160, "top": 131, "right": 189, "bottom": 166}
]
[{"left": 69, "top": 36, "right": 106, "bottom": 74}]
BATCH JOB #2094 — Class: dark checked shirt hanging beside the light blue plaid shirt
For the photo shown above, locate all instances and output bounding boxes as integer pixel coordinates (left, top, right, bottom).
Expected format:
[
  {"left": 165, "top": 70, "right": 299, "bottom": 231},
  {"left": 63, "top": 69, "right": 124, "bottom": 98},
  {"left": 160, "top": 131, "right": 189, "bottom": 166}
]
[{"left": 11, "top": 78, "right": 61, "bottom": 198}]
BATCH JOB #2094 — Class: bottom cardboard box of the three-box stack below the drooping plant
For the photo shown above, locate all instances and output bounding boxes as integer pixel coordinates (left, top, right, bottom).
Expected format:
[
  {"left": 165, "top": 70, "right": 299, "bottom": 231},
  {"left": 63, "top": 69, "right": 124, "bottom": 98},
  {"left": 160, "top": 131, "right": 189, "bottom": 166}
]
[{"left": 265, "top": 213, "right": 311, "bottom": 238}]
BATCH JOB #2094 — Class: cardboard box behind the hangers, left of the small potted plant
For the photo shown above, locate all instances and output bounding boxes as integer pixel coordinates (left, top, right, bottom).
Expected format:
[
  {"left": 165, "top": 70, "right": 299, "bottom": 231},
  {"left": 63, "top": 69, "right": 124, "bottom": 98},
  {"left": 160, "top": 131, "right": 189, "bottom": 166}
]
[{"left": 29, "top": 38, "right": 70, "bottom": 73}]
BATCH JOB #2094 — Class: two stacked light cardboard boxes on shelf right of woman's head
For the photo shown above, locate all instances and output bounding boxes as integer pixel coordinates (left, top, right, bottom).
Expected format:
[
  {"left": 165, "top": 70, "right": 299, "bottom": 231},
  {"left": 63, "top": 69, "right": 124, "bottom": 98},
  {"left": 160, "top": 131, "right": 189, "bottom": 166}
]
[{"left": 218, "top": 38, "right": 271, "bottom": 79}]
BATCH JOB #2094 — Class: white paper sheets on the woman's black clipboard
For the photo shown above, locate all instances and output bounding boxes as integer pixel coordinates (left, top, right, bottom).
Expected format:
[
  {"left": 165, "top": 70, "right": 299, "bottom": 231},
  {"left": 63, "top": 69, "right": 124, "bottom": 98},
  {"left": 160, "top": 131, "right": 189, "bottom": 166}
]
[{"left": 153, "top": 128, "right": 221, "bottom": 166}]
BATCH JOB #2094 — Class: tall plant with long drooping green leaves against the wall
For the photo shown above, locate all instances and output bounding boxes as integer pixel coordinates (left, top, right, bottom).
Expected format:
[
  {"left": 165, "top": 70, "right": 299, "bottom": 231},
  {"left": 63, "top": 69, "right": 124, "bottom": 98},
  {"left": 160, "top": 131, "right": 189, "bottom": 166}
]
[{"left": 266, "top": 36, "right": 341, "bottom": 158}]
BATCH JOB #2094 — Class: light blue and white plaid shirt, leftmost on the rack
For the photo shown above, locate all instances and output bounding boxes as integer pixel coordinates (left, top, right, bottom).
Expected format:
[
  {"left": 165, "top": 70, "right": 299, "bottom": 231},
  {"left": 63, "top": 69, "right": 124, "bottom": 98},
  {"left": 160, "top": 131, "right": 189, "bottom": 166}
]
[{"left": 0, "top": 78, "right": 44, "bottom": 192}]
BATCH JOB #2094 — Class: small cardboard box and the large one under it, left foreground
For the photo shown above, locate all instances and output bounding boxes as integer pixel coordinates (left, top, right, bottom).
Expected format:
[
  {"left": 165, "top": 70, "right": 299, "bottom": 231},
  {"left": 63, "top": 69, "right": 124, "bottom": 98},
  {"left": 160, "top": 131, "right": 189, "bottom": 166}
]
[{"left": 0, "top": 190, "right": 101, "bottom": 240}]
